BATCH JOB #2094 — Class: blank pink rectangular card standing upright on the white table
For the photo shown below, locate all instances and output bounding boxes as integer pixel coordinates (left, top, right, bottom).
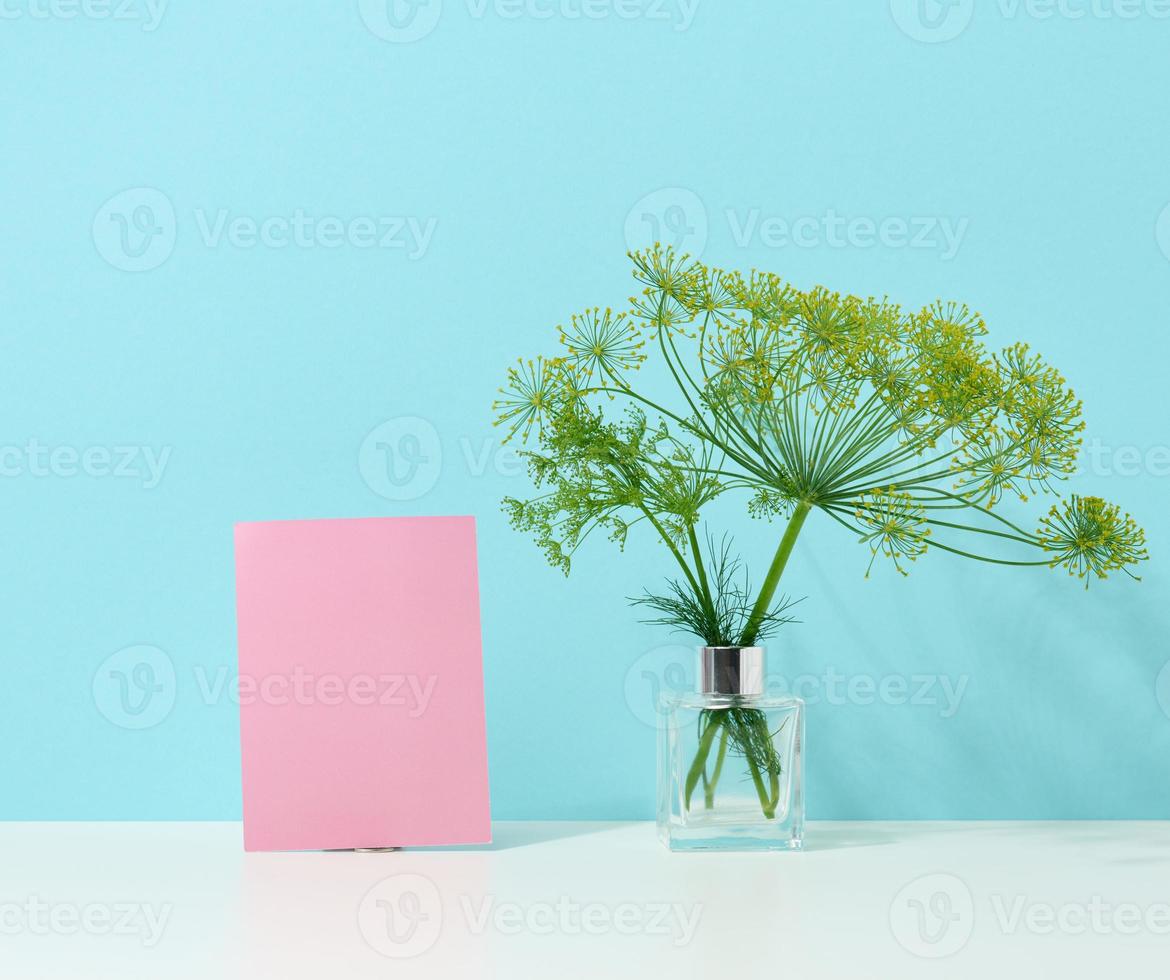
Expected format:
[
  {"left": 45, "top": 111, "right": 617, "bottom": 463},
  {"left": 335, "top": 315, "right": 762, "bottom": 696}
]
[{"left": 235, "top": 517, "right": 491, "bottom": 850}]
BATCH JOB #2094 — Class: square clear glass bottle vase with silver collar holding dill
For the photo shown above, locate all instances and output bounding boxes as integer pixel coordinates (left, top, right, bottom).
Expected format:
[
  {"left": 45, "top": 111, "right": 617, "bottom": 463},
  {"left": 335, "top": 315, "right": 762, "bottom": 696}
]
[{"left": 658, "top": 647, "right": 804, "bottom": 850}]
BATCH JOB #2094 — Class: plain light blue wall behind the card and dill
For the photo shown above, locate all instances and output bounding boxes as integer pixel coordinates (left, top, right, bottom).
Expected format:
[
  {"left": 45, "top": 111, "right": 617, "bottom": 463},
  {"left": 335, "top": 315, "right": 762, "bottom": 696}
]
[{"left": 0, "top": 0, "right": 1170, "bottom": 819}]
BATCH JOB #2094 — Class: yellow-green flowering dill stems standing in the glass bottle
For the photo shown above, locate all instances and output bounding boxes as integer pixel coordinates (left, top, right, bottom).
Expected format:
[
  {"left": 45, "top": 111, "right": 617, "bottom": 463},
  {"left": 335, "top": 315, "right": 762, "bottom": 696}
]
[{"left": 494, "top": 246, "right": 1147, "bottom": 815}]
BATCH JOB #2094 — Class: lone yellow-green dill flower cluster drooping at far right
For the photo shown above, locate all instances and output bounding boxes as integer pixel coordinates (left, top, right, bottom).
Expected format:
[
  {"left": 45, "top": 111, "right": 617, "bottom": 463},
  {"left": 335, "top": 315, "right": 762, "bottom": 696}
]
[{"left": 1035, "top": 495, "right": 1149, "bottom": 588}]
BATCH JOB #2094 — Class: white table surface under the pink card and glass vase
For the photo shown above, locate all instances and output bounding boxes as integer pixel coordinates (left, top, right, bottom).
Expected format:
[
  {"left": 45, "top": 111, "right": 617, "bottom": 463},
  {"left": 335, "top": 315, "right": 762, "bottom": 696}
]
[{"left": 0, "top": 822, "right": 1170, "bottom": 980}]
